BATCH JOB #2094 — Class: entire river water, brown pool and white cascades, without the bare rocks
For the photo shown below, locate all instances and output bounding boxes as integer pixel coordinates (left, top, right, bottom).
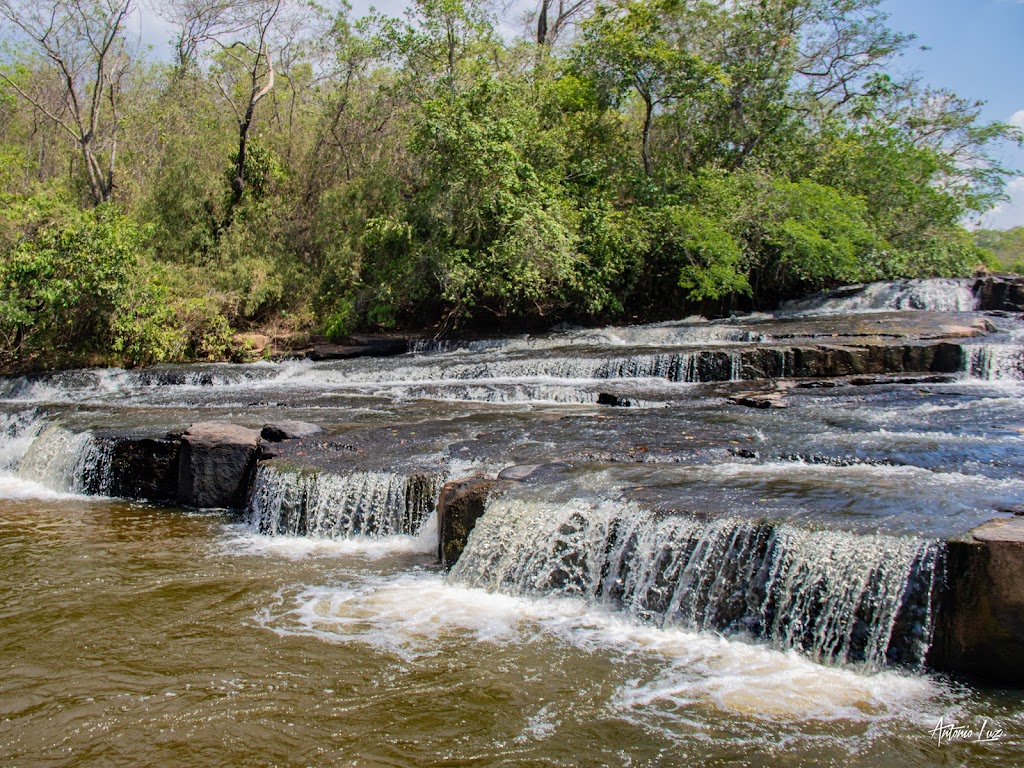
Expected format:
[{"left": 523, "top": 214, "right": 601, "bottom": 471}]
[{"left": 0, "top": 284, "right": 1024, "bottom": 766}]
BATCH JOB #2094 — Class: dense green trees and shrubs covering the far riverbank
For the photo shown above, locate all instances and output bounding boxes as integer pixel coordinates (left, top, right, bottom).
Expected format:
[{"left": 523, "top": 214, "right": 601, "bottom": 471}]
[{"left": 0, "top": 0, "right": 1020, "bottom": 367}]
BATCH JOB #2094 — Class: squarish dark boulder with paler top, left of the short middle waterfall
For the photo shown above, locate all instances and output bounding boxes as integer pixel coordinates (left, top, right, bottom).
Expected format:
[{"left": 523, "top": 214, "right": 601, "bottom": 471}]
[{"left": 178, "top": 422, "right": 260, "bottom": 509}]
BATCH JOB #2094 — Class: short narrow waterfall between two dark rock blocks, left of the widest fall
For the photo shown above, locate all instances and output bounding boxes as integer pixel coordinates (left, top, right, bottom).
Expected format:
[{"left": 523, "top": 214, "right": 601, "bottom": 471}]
[{"left": 246, "top": 466, "right": 437, "bottom": 539}]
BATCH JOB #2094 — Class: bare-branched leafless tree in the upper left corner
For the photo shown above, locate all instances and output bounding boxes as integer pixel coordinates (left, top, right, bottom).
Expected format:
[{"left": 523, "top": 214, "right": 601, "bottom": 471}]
[{"left": 0, "top": 0, "right": 134, "bottom": 205}]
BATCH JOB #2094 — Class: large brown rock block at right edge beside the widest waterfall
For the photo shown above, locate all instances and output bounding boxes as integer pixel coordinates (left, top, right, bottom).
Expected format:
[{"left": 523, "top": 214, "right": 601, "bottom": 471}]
[{"left": 929, "top": 517, "right": 1024, "bottom": 686}]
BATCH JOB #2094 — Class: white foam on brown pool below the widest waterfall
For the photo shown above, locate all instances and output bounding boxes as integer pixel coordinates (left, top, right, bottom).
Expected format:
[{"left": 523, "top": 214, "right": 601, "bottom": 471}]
[{"left": 258, "top": 573, "right": 941, "bottom": 730}]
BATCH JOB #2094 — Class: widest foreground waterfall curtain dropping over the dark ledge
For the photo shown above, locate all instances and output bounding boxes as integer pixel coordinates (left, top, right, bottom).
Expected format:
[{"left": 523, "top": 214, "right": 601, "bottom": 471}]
[{"left": 450, "top": 499, "right": 941, "bottom": 668}]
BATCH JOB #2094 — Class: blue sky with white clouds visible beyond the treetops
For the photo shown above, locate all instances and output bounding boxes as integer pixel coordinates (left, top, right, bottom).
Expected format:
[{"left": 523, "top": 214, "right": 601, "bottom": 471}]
[{"left": 140, "top": 0, "right": 1024, "bottom": 229}]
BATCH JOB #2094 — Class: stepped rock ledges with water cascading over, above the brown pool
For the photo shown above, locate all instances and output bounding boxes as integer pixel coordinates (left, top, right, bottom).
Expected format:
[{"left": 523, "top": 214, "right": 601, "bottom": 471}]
[{"left": 0, "top": 278, "right": 1024, "bottom": 685}]
